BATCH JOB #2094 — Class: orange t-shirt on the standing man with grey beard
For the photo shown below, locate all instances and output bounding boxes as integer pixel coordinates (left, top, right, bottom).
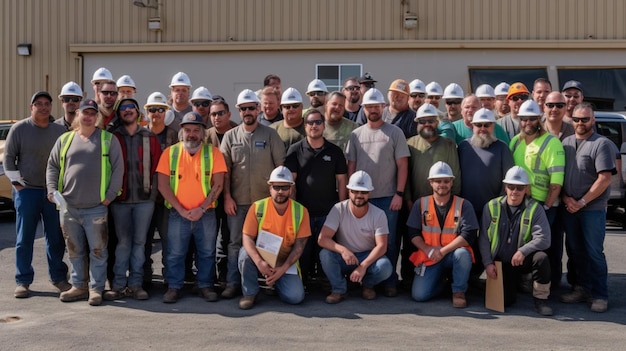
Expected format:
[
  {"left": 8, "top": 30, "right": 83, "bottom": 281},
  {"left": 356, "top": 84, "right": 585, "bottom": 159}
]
[{"left": 157, "top": 145, "right": 227, "bottom": 210}]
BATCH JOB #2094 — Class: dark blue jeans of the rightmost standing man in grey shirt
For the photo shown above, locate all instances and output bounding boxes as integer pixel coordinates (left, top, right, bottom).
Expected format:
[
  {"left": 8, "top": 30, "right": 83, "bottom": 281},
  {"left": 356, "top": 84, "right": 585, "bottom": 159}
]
[{"left": 563, "top": 210, "right": 609, "bottom": 299}]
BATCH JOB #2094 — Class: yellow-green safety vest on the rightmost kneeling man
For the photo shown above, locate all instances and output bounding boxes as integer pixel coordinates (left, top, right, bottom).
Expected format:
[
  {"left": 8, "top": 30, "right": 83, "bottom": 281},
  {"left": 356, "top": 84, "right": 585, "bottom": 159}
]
[{"left": 487, "top": 196, "right": 539, "bottom": 257}]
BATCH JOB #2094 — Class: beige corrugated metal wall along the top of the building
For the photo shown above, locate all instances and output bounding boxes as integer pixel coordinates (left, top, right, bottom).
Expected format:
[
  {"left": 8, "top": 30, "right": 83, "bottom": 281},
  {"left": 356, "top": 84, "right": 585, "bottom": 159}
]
[{"left": 0, "top": 0, "right": 626, "bottom": 119}]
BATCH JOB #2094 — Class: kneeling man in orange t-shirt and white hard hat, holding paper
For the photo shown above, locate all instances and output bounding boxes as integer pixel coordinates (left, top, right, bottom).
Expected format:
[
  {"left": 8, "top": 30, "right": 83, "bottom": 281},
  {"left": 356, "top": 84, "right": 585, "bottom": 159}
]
[{"left": 239, "top": 166, "right": 311, "bottom": 310}]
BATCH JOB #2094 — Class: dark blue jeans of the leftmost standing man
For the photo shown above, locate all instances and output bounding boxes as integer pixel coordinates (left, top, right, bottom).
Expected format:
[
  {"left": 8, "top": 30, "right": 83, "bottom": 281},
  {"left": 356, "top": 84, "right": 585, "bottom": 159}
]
[{"left": 13, "top": 188, "right": 67, "bottom": 285}]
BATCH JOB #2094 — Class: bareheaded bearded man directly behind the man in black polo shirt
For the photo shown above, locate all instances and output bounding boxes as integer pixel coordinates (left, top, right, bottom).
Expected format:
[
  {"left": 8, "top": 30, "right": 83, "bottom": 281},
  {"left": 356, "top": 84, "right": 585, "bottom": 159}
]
[{"left": 324, "top": 91, "right": 359, "bottom": 152}]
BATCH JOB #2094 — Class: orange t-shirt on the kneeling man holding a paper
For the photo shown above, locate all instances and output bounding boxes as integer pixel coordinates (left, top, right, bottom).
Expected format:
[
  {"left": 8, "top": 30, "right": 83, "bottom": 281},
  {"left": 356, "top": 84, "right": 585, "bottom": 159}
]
[{"left": 242, "top": 199, "right": 311, "bottom": 262}]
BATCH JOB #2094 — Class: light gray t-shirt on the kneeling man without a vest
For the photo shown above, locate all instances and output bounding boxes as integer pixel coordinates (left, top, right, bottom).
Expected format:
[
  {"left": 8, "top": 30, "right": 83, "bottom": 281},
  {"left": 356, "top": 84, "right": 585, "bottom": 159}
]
[{"left": 324, "top": 199, "right": 389, "bottom": 253}]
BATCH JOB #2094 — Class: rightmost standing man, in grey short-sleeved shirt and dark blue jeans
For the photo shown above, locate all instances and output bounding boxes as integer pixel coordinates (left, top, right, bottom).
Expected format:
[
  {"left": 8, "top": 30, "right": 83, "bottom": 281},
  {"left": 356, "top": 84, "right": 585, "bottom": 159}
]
[{"left": 561, "top": 102, "right": 617, "bottom": 312}]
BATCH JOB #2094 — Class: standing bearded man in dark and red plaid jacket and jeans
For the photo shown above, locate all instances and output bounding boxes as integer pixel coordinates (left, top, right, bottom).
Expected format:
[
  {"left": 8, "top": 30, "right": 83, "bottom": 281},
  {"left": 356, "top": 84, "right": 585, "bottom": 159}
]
[{"left": 103, "top": 98, "right": 161, "bottom": 301}]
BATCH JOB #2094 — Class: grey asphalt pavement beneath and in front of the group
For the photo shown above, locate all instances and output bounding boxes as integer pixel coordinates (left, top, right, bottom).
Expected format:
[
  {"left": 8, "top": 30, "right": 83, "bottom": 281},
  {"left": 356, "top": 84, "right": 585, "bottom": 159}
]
[{"left": 0, "top": 219, "right": 626, "bottom": 350}]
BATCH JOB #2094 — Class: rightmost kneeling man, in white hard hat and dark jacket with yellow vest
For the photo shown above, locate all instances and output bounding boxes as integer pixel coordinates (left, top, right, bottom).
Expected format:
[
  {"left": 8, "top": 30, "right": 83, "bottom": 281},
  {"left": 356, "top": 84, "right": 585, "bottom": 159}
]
[{"left": 478, "top": 166, "right": 552, "bottom": 316}]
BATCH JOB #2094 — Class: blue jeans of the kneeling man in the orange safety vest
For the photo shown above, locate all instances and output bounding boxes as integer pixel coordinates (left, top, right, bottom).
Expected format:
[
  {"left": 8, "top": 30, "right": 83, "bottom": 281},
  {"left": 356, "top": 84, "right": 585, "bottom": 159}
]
[{"left": 411, "top": 247, "right": 472, "bottom": 302}]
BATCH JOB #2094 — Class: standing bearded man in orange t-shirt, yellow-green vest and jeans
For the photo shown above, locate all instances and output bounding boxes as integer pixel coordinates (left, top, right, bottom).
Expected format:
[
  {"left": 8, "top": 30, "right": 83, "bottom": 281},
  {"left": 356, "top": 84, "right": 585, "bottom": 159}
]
[{"left": 157, "top": 112, "right": 227, "bottom": 303}]
